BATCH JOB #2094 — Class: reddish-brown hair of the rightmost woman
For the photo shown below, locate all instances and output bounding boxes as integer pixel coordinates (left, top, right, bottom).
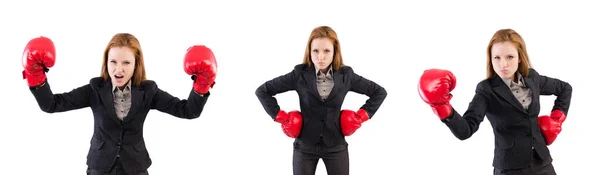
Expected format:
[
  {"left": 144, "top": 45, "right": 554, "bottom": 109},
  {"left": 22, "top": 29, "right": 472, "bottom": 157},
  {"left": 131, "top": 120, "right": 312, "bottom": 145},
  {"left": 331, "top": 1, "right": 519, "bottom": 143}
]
[{"left": 487, "top": 29, "right": 531, "bottom": 79}]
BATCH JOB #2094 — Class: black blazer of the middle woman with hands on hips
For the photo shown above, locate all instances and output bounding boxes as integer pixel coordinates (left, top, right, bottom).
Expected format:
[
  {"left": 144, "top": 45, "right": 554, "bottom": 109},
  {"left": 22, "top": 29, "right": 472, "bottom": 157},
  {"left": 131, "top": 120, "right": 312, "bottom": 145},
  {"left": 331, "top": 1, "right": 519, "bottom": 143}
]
[{"left": 256, "top": 64, "right": 387, "bottom": 145}]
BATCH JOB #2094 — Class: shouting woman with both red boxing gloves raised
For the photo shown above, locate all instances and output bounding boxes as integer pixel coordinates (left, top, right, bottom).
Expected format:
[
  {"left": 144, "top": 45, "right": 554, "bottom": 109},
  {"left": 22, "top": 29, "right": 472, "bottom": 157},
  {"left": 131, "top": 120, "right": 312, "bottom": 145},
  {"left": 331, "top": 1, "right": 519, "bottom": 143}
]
[{"left": 23, "top": 33, "right": 216, "bottom": 175}]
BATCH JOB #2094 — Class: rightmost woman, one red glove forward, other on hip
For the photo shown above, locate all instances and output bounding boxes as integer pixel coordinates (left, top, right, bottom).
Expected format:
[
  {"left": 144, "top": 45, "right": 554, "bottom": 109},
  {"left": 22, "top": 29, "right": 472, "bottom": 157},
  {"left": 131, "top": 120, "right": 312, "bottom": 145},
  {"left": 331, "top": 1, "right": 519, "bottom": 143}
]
[{"left": 419, "top": 29, "right": 572, "bottom": 175}]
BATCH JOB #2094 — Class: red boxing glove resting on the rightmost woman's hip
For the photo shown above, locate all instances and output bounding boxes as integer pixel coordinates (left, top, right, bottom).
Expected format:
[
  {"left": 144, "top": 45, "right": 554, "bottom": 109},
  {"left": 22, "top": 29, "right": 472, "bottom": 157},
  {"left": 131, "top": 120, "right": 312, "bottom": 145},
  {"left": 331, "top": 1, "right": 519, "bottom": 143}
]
[{"left": 538, "top": 109, "right": 567, "bottom": 145}]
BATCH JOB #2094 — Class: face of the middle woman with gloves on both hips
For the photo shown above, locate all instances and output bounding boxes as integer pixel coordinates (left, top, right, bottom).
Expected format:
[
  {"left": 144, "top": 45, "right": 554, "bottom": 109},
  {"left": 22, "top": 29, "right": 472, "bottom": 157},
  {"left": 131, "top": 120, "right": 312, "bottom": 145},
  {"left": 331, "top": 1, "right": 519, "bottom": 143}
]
[{"left": 310, "top": 38, "right": 334, "bottom": 72}]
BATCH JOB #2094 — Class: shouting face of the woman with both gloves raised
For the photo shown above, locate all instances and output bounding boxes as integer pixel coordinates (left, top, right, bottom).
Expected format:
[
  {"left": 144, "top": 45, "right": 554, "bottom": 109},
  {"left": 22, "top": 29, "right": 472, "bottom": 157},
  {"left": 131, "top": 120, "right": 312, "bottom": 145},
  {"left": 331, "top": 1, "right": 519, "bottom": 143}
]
[{"left": 106, "top": 47, "right": 135, "bottom": 87}]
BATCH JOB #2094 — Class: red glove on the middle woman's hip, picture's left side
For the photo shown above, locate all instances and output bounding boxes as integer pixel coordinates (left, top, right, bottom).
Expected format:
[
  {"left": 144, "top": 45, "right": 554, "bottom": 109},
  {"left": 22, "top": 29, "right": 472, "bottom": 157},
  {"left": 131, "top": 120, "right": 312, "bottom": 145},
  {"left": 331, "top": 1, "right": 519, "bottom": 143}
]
[{"left": 275, "top": 110, "right": 302, "bottom": 138}]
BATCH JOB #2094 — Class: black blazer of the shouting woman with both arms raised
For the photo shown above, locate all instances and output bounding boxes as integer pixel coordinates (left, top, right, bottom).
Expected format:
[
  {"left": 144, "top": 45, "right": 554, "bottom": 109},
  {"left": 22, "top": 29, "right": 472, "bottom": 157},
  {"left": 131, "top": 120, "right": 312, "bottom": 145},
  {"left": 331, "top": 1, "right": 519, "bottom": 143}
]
[{"left": 31, "top": 77, "right": 210, "bottom": 174}]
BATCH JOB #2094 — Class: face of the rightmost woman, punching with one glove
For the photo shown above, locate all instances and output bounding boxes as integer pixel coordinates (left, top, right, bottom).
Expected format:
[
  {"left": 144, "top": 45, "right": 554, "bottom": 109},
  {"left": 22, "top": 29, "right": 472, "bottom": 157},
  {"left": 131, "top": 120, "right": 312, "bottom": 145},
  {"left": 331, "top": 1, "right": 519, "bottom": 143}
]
[{"left": 491, "top": 41, "right": 521, "bottom": 79}]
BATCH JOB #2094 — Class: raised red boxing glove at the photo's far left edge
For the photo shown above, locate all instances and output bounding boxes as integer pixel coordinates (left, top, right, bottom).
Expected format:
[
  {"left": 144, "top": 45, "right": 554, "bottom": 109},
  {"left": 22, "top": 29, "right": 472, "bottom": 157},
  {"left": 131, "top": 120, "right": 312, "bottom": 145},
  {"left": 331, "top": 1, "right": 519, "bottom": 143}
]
[{"left": 22, "top": 36, "right": 56, "bottom": 87}]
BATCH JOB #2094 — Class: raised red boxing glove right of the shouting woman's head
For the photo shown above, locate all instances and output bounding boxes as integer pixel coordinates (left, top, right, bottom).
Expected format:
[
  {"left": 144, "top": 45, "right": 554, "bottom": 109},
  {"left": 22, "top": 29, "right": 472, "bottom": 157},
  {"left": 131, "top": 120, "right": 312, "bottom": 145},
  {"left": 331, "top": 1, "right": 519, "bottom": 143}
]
[{"left": 183, "top": 45, "right": 217, "bottom": 94}]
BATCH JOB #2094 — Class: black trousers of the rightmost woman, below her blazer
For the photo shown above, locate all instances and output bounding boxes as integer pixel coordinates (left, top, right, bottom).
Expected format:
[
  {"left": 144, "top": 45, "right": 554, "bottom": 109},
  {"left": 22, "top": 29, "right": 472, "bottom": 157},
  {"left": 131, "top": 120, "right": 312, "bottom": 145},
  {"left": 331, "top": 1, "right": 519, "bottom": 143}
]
[{"left": 494, "top": 150, "right": 556, "bottom": 175}]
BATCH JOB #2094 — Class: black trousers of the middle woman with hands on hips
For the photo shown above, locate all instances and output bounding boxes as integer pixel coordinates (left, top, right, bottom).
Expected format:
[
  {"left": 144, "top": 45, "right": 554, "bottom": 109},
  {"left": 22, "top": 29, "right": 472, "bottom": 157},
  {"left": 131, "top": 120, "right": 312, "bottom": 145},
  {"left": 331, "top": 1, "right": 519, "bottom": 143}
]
[{"left": 293, "top": 137, "right": 350, "bottom": 175}]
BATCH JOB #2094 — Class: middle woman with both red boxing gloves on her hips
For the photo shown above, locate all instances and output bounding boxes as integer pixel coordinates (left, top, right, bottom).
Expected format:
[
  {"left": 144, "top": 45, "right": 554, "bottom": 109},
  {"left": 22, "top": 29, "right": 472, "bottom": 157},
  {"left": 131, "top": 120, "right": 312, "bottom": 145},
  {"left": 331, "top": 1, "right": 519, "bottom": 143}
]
[{"left": 256, "top": 26, "right": 387, "bottom": 175}]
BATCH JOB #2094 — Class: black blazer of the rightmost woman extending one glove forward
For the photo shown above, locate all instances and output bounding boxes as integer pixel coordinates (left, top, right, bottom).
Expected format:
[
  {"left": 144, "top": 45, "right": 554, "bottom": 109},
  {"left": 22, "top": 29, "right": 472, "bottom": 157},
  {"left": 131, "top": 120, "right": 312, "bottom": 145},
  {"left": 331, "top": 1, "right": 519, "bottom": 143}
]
[{"left": 442, "top": 69, "right": 572, "bottom": 169}]
